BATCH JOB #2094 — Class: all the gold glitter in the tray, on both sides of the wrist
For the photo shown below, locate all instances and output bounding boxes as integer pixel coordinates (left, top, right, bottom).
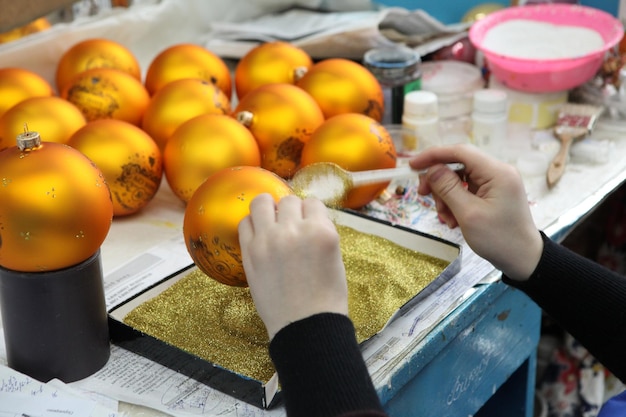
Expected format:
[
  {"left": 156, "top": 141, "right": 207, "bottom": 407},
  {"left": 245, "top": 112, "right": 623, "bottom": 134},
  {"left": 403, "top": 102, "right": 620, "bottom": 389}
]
[{"left": 124, "top": 225, "right": 448, "bottom": 382}]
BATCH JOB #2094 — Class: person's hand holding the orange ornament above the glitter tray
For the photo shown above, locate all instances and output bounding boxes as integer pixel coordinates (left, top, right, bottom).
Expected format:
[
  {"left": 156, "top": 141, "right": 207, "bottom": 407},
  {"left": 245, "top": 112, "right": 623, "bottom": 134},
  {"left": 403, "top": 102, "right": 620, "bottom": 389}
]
[{"left": 239, "top": 194, "right": 348, "bottom": 340}]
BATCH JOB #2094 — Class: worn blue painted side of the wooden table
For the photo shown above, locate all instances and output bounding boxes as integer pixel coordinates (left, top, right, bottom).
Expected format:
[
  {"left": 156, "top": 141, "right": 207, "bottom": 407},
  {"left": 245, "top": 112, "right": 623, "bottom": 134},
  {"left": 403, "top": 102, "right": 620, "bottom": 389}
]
[{"left": 378, "top": 281, "right": 541, "bottom": 417}]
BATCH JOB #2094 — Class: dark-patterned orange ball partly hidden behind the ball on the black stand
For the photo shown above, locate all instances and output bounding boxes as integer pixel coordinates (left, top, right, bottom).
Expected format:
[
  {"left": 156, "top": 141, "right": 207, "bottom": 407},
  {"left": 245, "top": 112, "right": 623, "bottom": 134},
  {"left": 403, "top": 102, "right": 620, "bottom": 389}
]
[{"left": 68, "top": 119, "right": 163, "bottom": 216}]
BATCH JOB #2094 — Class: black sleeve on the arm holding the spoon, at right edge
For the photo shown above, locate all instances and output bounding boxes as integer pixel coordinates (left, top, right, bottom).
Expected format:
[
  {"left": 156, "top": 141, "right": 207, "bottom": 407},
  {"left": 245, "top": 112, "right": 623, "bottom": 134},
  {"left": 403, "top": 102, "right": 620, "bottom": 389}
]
[{"left": 504, "top": 233, "right": 626, "bottom": 382}]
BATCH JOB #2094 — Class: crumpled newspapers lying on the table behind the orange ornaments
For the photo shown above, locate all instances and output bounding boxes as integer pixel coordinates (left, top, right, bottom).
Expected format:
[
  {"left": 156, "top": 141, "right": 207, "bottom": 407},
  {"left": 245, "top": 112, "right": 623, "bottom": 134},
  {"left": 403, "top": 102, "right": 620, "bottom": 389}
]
[{"left": 206, "top": 7, "right": 469, "bottom": 59}]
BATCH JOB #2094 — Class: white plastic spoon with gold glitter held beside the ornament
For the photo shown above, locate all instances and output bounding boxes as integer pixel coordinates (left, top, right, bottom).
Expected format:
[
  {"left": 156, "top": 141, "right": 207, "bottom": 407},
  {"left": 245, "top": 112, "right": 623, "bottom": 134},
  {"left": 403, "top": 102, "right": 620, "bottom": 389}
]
[{"left": 291, "top": 162, "right": 465, "bottom": 207}]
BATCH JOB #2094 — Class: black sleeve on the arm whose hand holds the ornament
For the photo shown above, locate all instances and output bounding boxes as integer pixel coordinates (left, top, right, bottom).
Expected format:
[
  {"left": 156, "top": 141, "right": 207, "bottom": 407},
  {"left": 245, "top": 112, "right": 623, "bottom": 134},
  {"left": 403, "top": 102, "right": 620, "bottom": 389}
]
[{"left": 270, "top": 313, "right": 384, "bottom": 417}]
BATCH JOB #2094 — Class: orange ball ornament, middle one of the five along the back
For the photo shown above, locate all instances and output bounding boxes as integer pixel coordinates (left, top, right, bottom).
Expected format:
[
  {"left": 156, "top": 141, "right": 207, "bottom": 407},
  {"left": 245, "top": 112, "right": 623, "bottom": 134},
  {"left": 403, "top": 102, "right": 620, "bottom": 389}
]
[{"left": 145, "top": 43, "right": 232, "bottom": 99}]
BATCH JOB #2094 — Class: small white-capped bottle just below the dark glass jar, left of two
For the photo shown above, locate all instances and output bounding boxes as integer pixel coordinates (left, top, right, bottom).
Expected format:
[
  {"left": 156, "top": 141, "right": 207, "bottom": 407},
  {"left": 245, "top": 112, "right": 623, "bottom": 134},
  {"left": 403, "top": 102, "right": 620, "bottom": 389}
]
[{"left": 402, "top": 91, "right": 440, "bottom": 152}]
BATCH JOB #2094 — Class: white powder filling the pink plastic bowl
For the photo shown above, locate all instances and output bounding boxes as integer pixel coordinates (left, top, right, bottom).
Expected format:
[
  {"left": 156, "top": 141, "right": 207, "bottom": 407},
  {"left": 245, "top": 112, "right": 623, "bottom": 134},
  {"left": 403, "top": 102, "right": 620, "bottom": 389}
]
[{"left": 483, "top": 19, "right": 604, "bottom": 59}]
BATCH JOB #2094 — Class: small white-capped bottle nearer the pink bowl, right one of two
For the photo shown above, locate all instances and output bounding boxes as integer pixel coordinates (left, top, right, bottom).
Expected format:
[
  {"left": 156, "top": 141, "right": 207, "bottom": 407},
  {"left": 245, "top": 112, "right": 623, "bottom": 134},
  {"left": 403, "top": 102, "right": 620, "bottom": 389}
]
[{"left": 472, "top": 89, "right": 508, "bottom": 157}]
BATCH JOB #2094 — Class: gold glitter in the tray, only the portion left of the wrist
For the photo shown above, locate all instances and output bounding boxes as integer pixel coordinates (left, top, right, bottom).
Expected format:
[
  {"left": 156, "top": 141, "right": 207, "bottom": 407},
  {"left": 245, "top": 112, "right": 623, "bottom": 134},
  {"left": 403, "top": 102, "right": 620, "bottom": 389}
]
[{"left": 124, "top": 270, "right": 274, "bottom": 381}]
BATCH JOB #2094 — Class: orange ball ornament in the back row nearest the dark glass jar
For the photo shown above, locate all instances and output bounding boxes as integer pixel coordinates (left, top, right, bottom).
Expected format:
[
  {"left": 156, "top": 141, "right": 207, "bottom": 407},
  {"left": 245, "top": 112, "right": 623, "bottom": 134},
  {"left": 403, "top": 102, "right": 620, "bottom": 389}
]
[{"left": 297, "top": 58, "right": 384, "bottom": 122}]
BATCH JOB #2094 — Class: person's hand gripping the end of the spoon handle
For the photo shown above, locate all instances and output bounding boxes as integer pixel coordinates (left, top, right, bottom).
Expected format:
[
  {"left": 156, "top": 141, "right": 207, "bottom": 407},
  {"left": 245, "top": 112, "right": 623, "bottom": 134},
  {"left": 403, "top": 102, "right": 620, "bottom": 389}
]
[{"left": 409, "top": 145, "right": 543, "bottom": 280}]
